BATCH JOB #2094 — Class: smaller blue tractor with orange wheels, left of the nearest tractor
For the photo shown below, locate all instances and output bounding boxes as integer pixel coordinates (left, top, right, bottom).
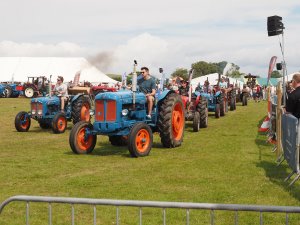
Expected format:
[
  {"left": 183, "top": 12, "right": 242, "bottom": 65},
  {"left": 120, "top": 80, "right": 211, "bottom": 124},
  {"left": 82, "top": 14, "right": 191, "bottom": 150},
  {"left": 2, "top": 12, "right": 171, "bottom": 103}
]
[{"left": 15, "top": 87, "right": 91, "bottom": 133}]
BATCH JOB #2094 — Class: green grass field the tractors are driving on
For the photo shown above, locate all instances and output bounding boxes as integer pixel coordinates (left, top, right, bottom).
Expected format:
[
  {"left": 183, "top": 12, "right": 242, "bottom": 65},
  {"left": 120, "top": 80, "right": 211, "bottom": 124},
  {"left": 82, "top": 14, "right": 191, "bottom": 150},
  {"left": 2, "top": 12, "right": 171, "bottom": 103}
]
[{"left": 0, "top": 98, "right": 300, "bottom": 225}]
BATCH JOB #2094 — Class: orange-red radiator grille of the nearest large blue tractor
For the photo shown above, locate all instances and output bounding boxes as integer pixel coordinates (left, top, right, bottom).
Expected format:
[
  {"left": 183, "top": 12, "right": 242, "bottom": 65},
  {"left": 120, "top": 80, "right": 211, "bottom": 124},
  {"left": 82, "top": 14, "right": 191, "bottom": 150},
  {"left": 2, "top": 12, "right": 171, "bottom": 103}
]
[{"left": 95, "top": 100, "right": 117, "bottom": 122}]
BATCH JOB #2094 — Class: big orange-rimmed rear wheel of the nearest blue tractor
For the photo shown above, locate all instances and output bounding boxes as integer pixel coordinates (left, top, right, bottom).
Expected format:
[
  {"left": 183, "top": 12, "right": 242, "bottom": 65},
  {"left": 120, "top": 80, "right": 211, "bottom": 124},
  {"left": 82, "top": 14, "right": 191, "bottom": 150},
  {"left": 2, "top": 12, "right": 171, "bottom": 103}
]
[{"left": 158, "top": 93, "right": 185, "bottom": 148}]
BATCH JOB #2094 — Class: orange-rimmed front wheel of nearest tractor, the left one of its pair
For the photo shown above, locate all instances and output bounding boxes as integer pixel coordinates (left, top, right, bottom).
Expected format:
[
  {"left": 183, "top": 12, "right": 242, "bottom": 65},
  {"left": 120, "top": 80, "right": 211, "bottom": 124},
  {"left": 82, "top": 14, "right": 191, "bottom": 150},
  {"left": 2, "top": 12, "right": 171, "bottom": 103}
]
[{"left": 69, "top": 121, "right": 97, "bottom": 154}]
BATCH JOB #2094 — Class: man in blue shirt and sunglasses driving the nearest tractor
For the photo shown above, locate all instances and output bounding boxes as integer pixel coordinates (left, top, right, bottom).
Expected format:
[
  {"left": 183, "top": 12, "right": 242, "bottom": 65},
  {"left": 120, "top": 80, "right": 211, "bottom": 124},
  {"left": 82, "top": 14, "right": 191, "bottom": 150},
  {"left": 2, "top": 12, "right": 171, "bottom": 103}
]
[{"left": 138, "top": 67, "right": 156, "bottom": 119}]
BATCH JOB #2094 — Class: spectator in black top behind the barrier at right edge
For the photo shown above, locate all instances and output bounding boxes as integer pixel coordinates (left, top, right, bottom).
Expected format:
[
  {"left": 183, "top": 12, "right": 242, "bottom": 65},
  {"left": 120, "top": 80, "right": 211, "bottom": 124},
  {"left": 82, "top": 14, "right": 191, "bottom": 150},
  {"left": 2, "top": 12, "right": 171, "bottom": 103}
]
[{"left": 286, "top": 73, "right": 300, "bottom": 119}]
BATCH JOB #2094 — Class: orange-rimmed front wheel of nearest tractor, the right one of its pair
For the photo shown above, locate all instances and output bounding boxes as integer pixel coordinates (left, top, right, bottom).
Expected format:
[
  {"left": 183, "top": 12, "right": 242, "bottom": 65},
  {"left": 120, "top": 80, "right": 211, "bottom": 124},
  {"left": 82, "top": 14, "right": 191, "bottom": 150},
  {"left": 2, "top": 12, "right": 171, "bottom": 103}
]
[{"left": 128, "top": 123, "right": 153, "bottom": 157}]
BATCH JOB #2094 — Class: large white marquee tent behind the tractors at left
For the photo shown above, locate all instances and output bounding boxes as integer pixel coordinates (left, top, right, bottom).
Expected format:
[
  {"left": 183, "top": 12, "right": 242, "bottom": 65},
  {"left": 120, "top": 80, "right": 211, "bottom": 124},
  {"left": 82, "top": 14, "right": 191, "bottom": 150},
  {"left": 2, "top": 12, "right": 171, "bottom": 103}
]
[{"left": 0, "top": 57, "right": 117, "bottom": 83}]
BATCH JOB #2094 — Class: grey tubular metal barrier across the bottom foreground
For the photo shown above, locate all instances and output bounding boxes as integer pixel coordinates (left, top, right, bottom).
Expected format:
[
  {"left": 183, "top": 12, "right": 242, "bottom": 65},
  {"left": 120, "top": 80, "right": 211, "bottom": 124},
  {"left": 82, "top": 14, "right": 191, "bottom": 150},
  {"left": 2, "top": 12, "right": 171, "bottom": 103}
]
[{"left": 0, "top": 195, "right": 300, "bottom": 225}]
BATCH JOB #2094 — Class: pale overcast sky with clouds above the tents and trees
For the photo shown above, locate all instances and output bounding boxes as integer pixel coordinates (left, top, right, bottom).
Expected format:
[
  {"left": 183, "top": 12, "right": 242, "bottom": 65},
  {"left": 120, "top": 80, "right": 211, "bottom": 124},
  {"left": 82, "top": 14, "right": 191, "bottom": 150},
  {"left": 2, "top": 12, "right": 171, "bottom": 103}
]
[{"left": 0, "top": 0, "right": 300, "bottom": 77}]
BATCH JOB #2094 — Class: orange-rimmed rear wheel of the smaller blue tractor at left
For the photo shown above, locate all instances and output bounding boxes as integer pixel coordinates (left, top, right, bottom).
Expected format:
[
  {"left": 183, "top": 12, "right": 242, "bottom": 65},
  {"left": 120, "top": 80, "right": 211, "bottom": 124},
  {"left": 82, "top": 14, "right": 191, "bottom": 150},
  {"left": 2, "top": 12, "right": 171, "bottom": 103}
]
[{"left": 72, "top": 96, "right": 91, "bottom": 124}]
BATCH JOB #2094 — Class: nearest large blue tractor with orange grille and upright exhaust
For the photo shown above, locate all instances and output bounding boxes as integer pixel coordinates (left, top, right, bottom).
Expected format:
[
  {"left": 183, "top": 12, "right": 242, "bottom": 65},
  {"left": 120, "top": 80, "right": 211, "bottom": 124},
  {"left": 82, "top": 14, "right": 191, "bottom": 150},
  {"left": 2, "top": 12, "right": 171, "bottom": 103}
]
[{"left": 69, "top": 61, "right": 185, "bottom": 157}]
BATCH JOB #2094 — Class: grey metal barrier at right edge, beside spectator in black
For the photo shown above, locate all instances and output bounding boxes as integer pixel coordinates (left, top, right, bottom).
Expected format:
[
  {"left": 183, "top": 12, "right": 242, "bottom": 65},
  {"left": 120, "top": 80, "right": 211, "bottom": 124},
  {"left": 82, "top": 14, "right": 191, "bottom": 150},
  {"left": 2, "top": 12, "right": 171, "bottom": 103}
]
[{"left": 281, "top": 114, "right": 300, "bottom": 185}]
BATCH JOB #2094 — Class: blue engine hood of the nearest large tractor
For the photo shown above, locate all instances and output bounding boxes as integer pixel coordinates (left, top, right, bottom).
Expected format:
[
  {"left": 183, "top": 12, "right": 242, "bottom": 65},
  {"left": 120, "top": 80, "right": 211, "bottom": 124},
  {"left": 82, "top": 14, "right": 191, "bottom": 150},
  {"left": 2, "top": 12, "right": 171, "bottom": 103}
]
[{"left": 95, "top": 91, "right": 146, "bottom": 104}]
